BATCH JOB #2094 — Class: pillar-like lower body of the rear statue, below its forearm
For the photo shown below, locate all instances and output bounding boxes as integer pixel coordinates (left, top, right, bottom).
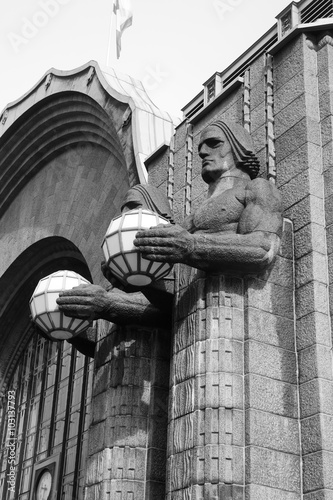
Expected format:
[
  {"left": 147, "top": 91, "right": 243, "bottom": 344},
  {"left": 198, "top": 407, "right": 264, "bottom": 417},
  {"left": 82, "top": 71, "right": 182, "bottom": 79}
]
[{"left": 86, "top": 321, "right": 170, "bottom": 500}]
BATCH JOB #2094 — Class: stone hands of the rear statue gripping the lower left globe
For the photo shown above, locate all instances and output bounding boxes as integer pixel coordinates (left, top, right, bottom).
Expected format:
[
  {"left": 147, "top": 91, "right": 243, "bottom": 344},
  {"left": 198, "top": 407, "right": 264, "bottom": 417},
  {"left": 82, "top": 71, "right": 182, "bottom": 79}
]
[{"left": 57, "top": 285, "right": 110, "bottom": 321}]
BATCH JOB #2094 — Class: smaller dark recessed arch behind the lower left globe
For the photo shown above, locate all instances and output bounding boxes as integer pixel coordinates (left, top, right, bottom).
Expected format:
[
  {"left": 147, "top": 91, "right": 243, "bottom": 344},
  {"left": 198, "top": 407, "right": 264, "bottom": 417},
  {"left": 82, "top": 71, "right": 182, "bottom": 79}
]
[{"left": 0, "top": 237, "right": 92, "bottom": 393}]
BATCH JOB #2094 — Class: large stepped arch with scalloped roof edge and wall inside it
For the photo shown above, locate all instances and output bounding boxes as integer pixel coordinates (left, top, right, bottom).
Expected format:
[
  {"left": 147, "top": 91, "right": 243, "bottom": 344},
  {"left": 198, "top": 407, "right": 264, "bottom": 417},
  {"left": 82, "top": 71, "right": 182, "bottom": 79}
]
[{"left": 0, "top": 61, "right": 173, "bottom": 292}]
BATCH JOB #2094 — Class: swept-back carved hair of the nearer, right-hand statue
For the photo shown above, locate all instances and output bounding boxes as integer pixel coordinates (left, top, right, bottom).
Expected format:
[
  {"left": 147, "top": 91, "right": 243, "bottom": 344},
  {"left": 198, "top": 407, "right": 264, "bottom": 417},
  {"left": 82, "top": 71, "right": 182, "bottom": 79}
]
[{"left": 209, "top": 120, "right": 260, "bottom": 179}]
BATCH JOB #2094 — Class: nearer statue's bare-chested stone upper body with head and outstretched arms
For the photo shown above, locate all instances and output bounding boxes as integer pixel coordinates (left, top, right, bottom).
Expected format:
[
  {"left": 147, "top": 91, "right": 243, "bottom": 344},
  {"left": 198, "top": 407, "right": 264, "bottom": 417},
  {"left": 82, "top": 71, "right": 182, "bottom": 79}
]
[{"left": 135, "top": 121, "right": 282, "bottom": 273}]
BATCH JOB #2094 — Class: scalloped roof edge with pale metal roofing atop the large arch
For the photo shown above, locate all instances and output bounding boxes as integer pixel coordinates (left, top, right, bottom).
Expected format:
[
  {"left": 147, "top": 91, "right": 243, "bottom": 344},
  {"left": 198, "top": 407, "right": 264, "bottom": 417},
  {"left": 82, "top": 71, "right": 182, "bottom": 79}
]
[{"left": 0, "top": 61, "right": 175, "bottom": 183}]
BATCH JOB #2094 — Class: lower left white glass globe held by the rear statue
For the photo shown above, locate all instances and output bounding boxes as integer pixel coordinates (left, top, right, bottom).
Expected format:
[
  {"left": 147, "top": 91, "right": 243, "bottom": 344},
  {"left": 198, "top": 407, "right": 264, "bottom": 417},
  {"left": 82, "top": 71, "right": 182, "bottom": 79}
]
[{"left": 29, "top": 271, "right": 91, "bottom": 340}]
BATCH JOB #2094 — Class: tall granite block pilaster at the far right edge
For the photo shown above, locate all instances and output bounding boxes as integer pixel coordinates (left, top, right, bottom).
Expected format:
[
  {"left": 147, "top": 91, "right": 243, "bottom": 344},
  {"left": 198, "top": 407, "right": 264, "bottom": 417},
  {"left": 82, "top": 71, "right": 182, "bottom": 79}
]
[{"left": 274, "top": 32, "right": 333, "bottom": 500}]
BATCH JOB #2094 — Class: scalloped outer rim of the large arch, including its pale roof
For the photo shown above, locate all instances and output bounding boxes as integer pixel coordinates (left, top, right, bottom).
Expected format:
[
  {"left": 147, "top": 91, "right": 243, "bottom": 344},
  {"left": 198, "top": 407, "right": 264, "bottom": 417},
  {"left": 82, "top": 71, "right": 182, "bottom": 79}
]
[{"left": 0, "top": 61, "right": 175, "bottom": 191}]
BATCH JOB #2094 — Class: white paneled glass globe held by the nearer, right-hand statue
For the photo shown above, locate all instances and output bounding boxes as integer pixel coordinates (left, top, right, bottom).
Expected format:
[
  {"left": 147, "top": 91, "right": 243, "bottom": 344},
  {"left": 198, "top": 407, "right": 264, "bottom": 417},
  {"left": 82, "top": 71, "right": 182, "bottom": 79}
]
[{"left": 102, "top": 208, "right": 172, "bottom": 287}]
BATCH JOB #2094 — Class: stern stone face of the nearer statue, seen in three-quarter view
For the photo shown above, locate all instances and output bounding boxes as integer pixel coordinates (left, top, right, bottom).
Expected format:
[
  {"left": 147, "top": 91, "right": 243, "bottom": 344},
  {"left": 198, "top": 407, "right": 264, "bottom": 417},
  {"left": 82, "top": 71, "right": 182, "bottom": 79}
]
[{"left": 199, "top": 125, "right": 236, "bottom": 184}]
